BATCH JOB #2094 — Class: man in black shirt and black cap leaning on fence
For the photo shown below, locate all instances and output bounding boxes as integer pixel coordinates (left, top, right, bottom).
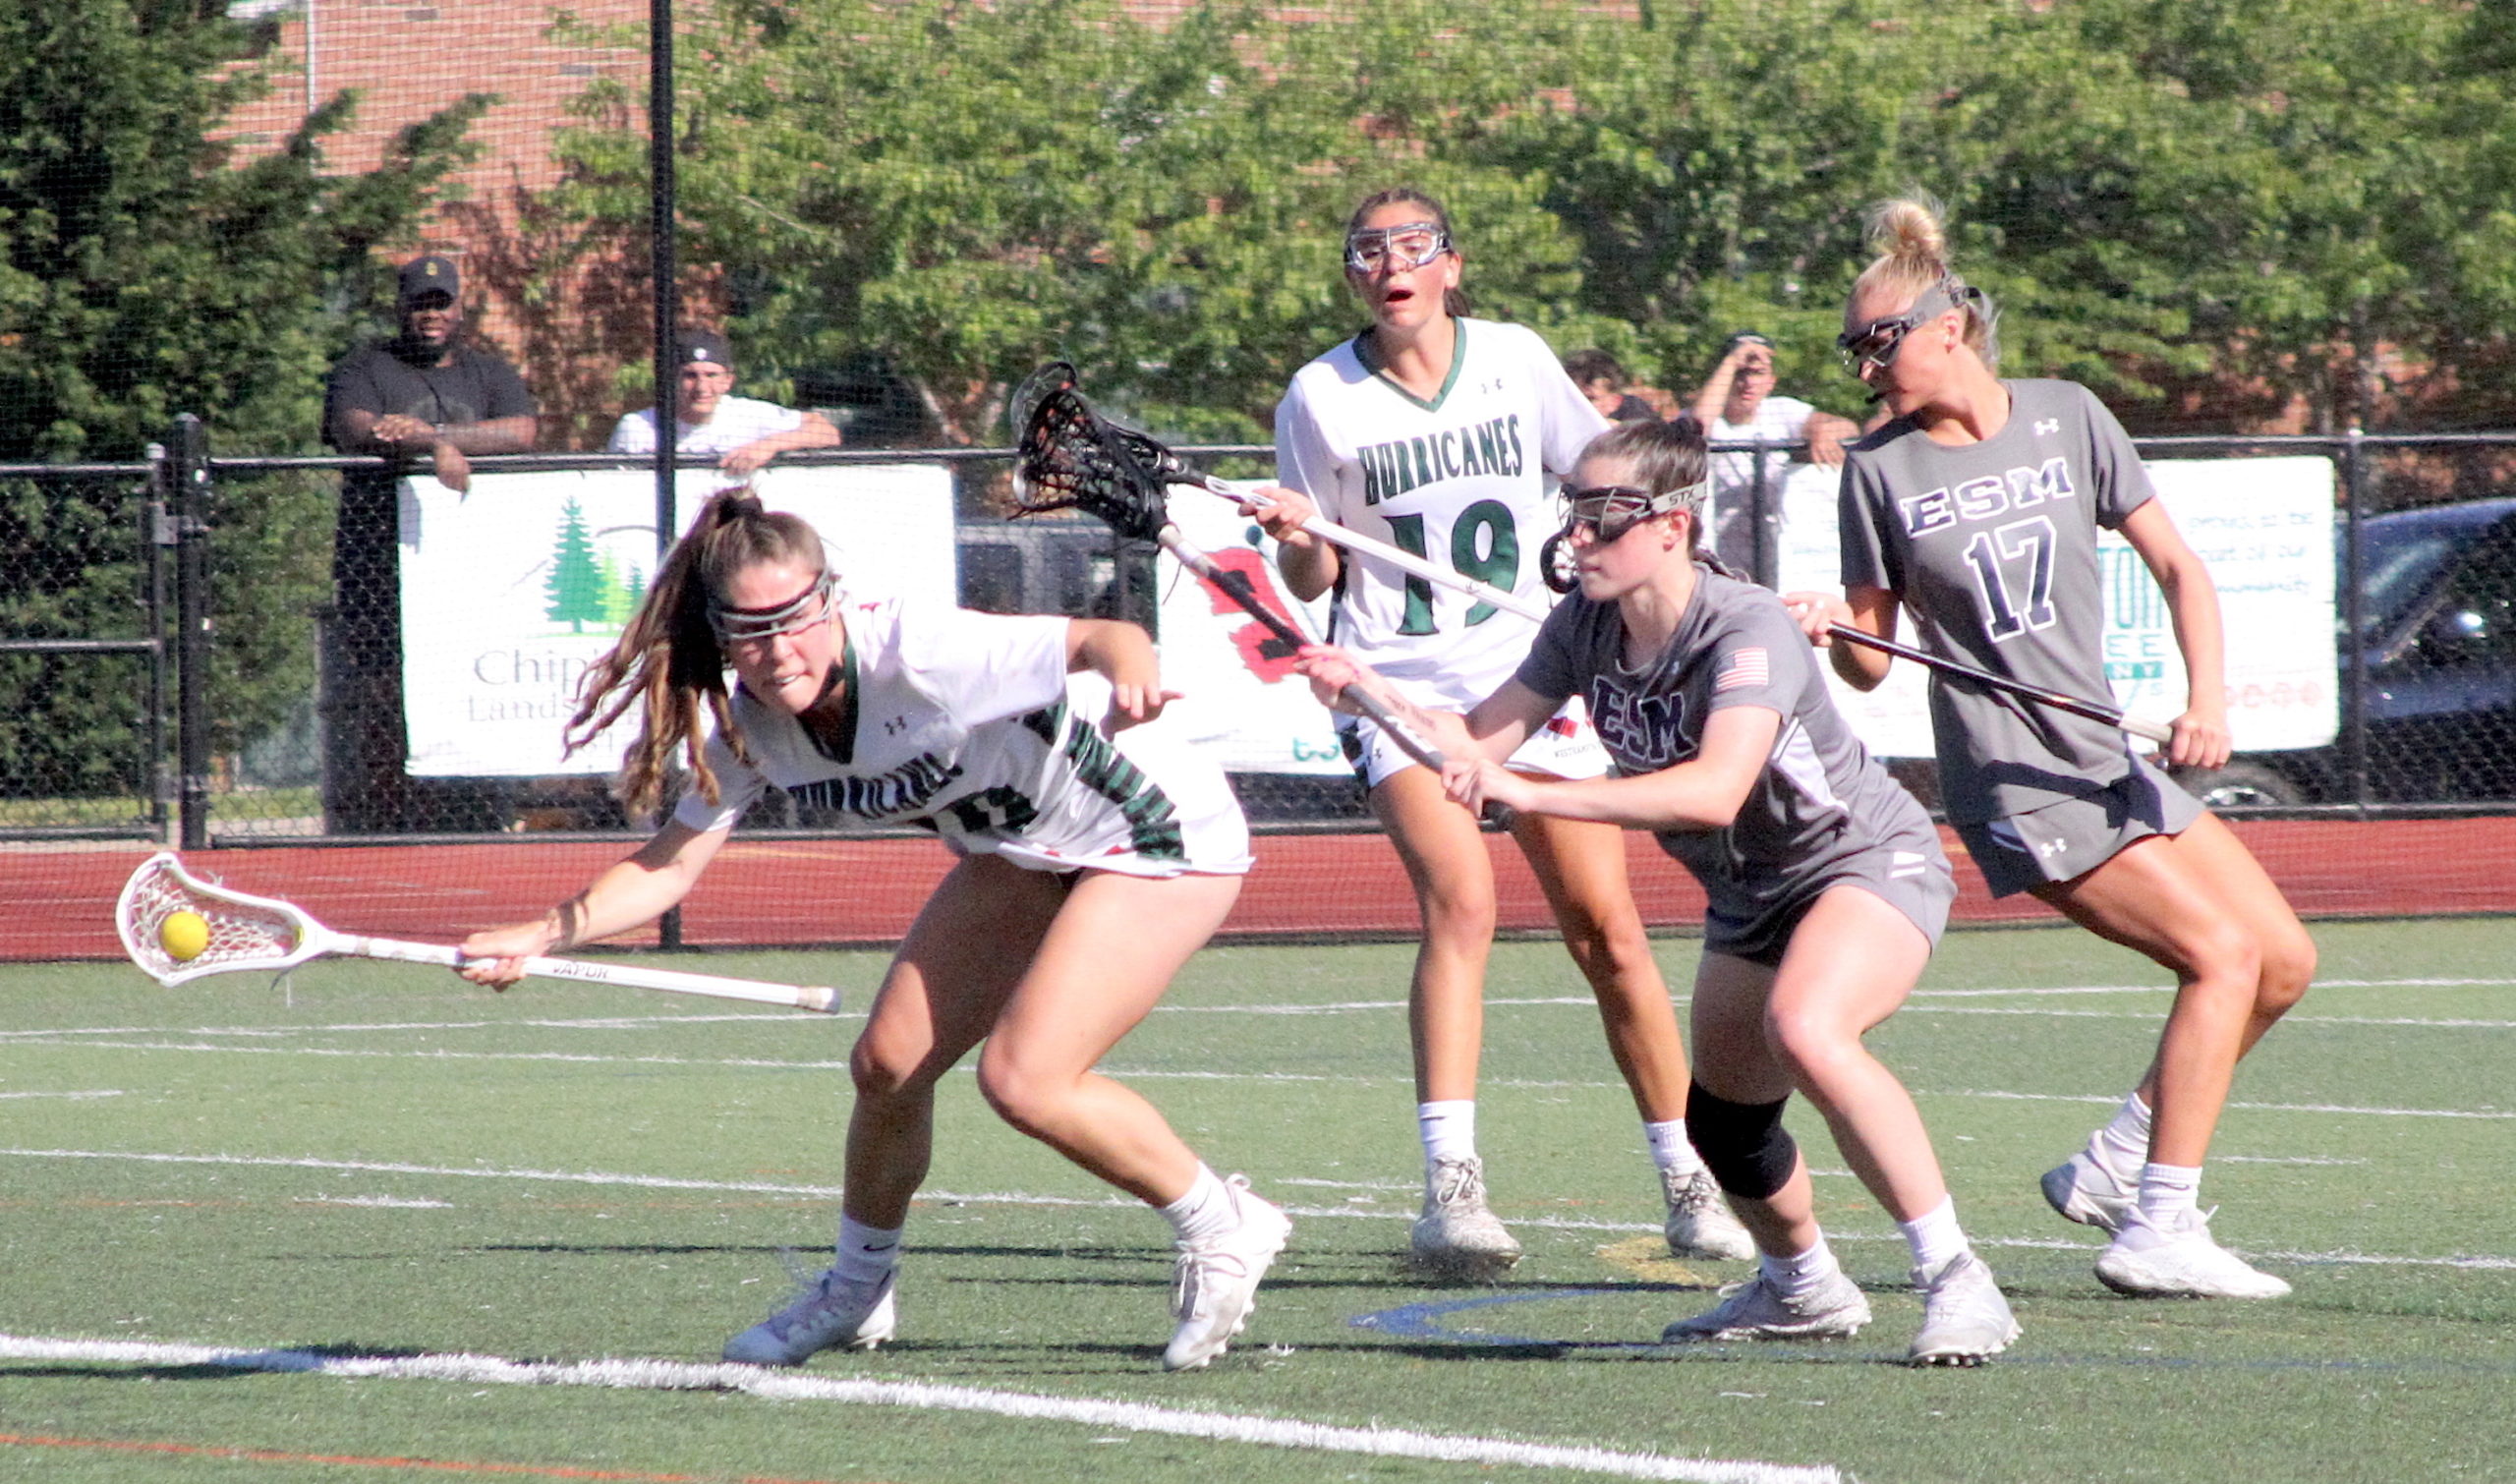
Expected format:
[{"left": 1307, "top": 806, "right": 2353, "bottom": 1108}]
[{"left": 322, "top": 254, "right": 539, "bottom": 830}]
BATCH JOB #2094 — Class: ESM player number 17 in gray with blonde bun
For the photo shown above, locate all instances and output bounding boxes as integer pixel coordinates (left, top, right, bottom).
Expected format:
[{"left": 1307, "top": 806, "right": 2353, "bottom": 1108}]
[{"left": 1792, "top": 201, "right": 2315, "bottom": 1298}]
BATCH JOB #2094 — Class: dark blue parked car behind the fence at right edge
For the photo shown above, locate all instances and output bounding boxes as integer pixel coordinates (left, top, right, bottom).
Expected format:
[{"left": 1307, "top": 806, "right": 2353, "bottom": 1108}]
[{"left": 2184, "top": 498, "right": 2516, "bottom": 808}]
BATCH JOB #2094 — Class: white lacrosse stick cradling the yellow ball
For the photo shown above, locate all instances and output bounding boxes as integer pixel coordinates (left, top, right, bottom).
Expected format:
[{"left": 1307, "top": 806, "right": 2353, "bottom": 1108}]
[{"left": 113, "top": 850, "right": 837, "bottom": 1013}]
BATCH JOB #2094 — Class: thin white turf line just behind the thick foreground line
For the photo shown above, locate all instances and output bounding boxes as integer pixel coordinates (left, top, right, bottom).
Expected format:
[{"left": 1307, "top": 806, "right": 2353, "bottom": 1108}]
[{"left": 0, "top": 1150, "right": 2516, "bottom": 1273}]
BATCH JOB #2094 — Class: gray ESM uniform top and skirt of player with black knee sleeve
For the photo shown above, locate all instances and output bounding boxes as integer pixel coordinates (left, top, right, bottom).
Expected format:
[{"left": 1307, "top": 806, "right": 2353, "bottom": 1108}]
[{"left": 1517, "top": 566, "right": 1945, "bottom": 921}]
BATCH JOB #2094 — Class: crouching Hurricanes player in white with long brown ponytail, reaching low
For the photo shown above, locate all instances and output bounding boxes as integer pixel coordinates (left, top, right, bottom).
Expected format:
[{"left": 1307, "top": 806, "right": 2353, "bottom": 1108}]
[{"left": 463, "top": 490, "right": 1290, "bottom": 1371}]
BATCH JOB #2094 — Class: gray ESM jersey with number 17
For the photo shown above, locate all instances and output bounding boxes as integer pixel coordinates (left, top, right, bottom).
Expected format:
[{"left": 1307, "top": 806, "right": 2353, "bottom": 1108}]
[{"left": 1839, "top": 379, "right": 2156, "bottom": 823}]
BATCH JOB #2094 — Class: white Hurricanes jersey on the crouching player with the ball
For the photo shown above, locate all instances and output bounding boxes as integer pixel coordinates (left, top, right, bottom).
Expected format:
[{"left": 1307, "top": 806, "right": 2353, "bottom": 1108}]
[{"left": 674, "top": 597, "right": 1250, "bottom": 876}]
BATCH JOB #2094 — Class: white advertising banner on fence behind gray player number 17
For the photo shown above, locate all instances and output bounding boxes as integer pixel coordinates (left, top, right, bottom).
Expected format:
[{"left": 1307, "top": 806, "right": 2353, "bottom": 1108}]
[{"left": 1776, "top": 458, "right": 2340, "bottom": 757}]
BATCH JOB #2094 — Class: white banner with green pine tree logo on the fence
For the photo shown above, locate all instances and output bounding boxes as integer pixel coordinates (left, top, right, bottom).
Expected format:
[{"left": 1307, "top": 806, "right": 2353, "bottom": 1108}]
[{"left": 403, "top": 463, "right": 958, "bottom": 777}]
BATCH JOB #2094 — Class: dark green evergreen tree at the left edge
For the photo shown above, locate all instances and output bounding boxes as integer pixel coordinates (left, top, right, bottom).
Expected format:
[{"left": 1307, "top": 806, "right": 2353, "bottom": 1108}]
[{"left": 0, "top": 0, "right": 486, "bottom": 795}]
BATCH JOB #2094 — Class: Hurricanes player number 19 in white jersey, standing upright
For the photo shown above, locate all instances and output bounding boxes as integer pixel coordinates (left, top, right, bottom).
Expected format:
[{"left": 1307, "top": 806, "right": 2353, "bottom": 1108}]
[{"left": 1245, "top": 189, "right": 1753, "bottom": 1278}]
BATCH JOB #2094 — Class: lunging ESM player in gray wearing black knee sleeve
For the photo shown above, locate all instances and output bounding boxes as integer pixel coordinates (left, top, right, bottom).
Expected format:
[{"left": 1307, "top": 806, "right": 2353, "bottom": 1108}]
[{"left": 1303, "top": 415, "right": 2018, "bottom": 1366}]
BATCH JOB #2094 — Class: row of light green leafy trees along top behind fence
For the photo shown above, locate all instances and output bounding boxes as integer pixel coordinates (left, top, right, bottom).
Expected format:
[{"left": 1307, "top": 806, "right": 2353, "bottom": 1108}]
[{"left": 555, "top": 0, "right": 2516, "bottom": 437}]
